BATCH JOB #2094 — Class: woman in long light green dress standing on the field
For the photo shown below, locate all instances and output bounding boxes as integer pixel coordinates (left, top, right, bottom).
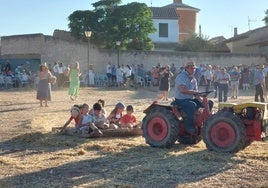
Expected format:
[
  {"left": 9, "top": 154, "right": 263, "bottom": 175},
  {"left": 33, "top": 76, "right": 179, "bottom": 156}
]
[{"left": 68, "top": 62, "right": 81, "bottom": 100}]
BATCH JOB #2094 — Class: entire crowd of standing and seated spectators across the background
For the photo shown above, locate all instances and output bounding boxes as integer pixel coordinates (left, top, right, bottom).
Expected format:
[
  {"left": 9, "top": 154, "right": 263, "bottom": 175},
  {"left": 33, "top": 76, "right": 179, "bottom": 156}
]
[{"left": 0, "top": 58, "right": 268, "bottom": 106}]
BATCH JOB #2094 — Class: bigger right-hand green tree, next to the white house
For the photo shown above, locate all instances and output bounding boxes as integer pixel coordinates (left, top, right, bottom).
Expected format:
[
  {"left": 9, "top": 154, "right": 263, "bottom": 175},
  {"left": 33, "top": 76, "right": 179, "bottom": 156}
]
[{"left": 107, "top": 2, "right": 156, "bottom": 50}]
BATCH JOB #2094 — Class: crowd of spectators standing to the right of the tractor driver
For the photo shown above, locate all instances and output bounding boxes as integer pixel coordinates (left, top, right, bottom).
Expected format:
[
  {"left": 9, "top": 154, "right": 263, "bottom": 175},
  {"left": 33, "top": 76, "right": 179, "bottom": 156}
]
[{"left": 195, "top": 65, "right": 268, "bottom": 102}]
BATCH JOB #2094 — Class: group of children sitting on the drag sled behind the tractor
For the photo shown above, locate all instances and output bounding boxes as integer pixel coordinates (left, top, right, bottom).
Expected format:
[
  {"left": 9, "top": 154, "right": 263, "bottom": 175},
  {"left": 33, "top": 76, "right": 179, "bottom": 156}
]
[{"left": 61, "top": 99, "right": 139, "bottom": 136}]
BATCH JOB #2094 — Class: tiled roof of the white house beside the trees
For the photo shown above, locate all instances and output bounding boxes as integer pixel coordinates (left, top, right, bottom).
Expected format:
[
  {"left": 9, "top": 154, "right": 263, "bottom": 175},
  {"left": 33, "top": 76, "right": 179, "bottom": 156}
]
[{"left": 151, "top": 7, "right": 178, "bottom": 19}]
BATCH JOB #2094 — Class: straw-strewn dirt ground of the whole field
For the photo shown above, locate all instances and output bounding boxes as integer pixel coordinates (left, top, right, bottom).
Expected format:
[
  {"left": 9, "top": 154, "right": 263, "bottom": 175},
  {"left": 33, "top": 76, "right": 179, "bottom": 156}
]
[{"left": 0, "top": 88, "right": 268, "bottom": 188}]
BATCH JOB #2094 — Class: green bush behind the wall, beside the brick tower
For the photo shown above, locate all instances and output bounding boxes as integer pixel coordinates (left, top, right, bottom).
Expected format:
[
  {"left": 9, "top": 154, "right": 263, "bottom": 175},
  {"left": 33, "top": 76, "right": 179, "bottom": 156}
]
[{"left": 176, "top": 34, "right": 215, "bottom": 52}]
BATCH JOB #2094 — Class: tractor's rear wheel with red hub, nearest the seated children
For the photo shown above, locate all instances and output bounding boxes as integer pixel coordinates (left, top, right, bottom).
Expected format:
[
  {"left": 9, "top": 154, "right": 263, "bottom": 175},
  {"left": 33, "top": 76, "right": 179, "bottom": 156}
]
[{"left": 142, "top": 107, "right": 179, "bottom": 148}]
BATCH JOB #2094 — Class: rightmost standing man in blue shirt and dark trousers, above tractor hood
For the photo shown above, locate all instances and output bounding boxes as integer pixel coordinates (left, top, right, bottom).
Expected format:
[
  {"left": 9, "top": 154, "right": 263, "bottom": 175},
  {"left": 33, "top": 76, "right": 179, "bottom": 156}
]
[{"left": 253, "top": 65, "right": 265, "bottom": 102}]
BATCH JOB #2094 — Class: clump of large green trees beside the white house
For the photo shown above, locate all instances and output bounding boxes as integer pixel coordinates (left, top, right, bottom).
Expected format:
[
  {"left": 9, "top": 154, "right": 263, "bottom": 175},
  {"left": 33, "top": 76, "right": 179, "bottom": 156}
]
[{"left": 69, "top": 0, "right": 156, "bottom": 50}]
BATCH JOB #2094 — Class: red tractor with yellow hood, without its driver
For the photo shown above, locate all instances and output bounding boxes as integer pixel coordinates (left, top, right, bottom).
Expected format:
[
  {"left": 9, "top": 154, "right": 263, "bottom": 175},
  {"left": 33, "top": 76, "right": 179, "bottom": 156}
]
[{"left": 142, "top": 91, "right": 268, "bottom": 152}]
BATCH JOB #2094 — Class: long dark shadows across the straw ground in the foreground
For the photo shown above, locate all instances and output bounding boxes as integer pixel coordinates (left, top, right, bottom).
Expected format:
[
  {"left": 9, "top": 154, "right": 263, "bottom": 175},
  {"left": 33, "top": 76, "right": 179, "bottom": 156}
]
[{"left": 0, "top": 132, "right": 239, "bottom": 188}]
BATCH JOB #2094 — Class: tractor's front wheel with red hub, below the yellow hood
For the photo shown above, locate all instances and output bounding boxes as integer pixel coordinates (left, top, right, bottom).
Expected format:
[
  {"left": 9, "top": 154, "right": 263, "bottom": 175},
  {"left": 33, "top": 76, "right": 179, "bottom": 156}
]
[{"left": 202, "top": 112, "right": 246, "bottom": 152}]
